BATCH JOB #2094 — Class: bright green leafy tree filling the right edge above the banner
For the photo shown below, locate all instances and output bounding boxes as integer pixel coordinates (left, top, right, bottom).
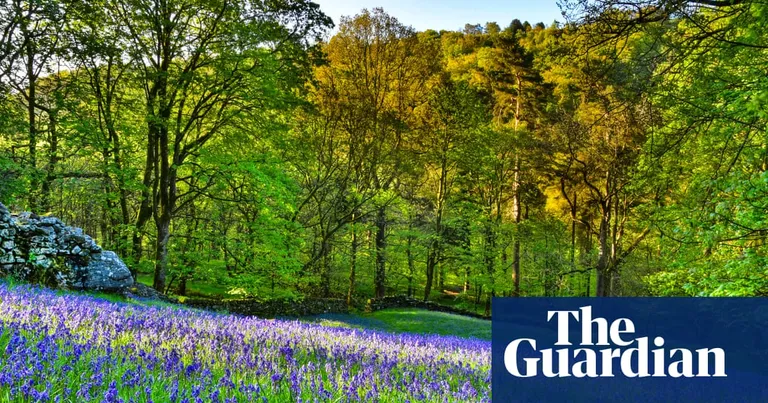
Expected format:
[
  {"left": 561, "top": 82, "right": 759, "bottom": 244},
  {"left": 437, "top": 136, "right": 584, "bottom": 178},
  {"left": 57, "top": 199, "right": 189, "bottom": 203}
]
[{"left": 569, "top": 1, "right": 768, "bottom": 295}]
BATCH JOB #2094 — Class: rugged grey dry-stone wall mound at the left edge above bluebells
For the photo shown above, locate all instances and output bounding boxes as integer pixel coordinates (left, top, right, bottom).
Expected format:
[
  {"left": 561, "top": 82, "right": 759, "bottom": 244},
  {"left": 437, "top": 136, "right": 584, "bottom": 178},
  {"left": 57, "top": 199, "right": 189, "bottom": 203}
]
[{"left": 0, "top": 204, "right": 133, "bottom": 291}]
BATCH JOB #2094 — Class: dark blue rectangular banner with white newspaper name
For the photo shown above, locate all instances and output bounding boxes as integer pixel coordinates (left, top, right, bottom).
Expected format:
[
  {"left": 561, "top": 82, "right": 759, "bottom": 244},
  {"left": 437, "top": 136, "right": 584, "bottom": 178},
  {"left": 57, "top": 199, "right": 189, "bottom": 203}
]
[{"left": 492, "top": 298, "right": 768, "bottom": 403}]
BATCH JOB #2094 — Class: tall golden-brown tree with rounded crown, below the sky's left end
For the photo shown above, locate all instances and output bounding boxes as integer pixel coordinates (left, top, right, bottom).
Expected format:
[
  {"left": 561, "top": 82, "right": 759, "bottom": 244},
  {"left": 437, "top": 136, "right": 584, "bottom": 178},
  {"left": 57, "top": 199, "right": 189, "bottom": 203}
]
[{"left": 317, "top": 9, "right": 437, "bottom": 297}]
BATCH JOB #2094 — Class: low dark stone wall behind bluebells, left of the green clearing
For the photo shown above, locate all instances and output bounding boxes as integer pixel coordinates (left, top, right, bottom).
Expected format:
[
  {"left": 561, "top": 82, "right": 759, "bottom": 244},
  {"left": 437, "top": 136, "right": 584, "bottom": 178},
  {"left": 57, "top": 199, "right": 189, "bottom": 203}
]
[{"left": 183, "top": 298, "right": 349, "bottom": 318}]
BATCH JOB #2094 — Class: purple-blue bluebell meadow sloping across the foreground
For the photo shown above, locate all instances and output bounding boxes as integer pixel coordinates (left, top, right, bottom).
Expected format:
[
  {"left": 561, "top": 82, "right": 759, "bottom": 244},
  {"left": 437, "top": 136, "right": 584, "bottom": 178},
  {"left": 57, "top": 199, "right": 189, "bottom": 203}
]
[{"left": 0, "top": 284, "right": 491, "bottom": 403}]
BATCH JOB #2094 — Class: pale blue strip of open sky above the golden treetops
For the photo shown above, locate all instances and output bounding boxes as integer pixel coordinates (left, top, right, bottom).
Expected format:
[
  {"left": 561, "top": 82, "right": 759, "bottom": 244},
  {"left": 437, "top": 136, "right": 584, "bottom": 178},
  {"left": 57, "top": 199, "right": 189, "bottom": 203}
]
[{"left": 314, "top": 0, "right": 564, "bottom": 31}]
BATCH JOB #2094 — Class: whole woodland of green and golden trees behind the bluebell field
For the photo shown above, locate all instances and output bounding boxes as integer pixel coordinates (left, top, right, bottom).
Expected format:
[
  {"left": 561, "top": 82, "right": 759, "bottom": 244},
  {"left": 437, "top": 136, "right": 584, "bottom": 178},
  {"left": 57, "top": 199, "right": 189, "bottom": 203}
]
[{"left": 0, "top": 0, "right": 768, "bottom": 313}]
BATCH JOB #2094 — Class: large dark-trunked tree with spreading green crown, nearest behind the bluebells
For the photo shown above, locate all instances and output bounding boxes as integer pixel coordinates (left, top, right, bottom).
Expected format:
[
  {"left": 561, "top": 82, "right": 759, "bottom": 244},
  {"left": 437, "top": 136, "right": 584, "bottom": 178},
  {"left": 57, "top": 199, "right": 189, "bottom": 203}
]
[{"left": 109, "top": 0, "right": 331, "bottom": 291}]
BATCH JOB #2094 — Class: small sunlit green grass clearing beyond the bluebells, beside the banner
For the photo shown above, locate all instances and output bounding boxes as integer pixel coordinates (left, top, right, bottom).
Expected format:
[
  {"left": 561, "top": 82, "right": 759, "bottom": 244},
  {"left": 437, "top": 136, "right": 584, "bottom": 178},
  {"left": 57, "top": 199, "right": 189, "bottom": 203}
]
[{"left": 303, "top": 308, "right": 491, "bottom": 340}]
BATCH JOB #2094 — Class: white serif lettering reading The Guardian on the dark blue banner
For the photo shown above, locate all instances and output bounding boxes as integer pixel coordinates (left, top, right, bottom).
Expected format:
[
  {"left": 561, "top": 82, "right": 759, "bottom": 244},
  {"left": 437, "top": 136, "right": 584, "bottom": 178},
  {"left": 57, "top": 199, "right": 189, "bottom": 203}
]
[{"left": 504, "top": 306, "right": 727, "bottom": 378}]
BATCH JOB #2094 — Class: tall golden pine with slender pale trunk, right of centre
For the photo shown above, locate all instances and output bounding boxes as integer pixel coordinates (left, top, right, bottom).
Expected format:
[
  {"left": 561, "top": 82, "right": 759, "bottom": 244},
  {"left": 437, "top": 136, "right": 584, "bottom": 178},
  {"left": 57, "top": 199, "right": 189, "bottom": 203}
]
[{"left": 440, "top": 20, "right": 542, "bottom": 295}]
